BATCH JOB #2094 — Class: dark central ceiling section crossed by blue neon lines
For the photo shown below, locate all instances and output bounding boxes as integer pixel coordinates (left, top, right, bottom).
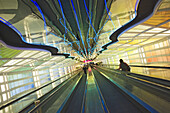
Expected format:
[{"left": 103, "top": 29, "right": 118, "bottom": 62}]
[{"left": 26, "top": 0, "right": 115, "bottom": 58}]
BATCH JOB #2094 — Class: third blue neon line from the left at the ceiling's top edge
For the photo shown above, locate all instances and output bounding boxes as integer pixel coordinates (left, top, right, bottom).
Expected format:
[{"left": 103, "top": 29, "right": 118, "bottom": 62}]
[{"left": 71, "top": 0, "right": 87, "bottom": 56}]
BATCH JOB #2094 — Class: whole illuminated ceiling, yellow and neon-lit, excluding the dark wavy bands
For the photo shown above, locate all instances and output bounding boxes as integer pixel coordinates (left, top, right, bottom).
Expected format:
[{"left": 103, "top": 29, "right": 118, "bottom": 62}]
[{"left": 0, "top": 0, "right": 170, "bottom": 71}]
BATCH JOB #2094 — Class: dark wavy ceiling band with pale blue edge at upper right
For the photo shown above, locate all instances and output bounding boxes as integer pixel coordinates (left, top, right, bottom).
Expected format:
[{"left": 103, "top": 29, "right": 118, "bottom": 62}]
[{"left": 100, "top": 0, "right": 162, "bottom": 50}]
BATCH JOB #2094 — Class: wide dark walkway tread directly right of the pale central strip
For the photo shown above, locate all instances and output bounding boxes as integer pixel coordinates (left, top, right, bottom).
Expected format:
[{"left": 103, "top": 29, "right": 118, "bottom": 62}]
[{"left": 93, "top": 70, "right": 148, "bottom": 113}]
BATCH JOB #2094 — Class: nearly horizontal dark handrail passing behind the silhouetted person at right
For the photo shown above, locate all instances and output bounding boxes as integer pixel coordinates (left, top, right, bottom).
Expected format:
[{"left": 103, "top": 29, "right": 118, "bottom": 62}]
[{"left": 100, "top": 64, "right": 170, "bottom": 69}]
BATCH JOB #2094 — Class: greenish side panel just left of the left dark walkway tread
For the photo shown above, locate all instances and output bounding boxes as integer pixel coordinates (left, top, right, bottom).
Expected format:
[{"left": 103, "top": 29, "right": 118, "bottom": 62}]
[{"left": 29, "top": 75, "right": 80, "bottom": 113}]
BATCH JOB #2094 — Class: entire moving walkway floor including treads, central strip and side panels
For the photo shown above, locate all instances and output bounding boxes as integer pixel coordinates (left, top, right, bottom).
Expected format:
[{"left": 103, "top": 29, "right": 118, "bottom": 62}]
[{"left": 0, "top": 67, "right": 170, "bottom": 113}]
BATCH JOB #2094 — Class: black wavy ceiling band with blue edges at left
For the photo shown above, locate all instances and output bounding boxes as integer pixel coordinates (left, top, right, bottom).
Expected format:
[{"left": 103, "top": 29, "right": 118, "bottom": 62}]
[{"left": 0, "top": 21, "right": 70, "bottom": 58}]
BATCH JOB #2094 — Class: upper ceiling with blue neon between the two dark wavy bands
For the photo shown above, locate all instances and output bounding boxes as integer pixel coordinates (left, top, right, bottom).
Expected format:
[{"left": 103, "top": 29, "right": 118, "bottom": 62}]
[{"left": 0, "top": 0, "right": 138, "bottom": 59}]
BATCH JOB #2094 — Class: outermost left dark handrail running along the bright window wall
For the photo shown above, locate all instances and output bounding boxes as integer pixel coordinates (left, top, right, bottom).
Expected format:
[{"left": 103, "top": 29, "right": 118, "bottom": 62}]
[{"left": 0, "top": 70, "right": 79, "bottom": 110}]
